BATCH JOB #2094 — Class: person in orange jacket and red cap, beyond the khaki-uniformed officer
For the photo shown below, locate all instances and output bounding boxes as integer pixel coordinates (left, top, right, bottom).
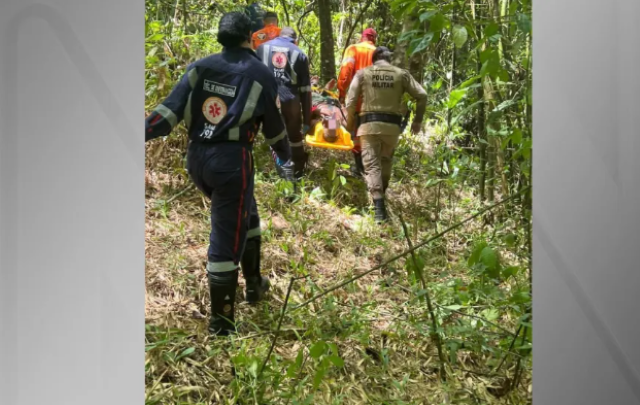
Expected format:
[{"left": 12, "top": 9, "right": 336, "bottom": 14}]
[{"left": 338, "top": 28, "right": 378, "bottom": 176}]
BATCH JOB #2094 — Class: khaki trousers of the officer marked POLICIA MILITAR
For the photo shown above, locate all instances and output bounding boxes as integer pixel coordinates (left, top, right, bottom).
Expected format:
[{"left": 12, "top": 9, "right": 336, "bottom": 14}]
[{"left": 359, "top": 135, "right": 399, "bottom": 199}]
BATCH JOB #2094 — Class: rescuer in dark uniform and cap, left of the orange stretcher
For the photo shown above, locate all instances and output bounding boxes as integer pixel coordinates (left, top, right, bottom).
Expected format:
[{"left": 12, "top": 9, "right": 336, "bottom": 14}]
[{"left": 256, "top": 27, "right": 311, "bottom": 177}]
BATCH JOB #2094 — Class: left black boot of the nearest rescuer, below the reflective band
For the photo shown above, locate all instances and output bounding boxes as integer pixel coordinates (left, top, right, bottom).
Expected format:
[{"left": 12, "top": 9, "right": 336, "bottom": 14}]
[{"left": 208, "top": 269, "right": 238, "bottom": 336}]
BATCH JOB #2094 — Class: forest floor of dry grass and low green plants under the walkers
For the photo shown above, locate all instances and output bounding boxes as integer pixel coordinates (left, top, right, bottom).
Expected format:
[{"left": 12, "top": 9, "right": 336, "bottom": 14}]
[{"left": 145, "top": 128, "right": 531, "bottom": 404}]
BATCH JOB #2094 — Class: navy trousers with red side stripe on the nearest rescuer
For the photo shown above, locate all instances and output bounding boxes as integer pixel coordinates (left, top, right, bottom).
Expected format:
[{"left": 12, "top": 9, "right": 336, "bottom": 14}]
[{"left": 187, "top": 142, "right": 260, "bottom": 272}]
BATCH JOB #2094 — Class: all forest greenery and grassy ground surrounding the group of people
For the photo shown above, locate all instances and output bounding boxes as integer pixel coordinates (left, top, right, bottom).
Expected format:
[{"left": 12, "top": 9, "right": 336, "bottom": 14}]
[{"left": 145, "top": 0, "right": 532, "bottom": 405}]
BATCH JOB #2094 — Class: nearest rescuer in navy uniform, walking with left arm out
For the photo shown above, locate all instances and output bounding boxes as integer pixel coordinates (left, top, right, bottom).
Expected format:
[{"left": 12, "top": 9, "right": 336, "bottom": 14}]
[{"left": 145, "top": 12, "right": 293, "bottom": 335}]
